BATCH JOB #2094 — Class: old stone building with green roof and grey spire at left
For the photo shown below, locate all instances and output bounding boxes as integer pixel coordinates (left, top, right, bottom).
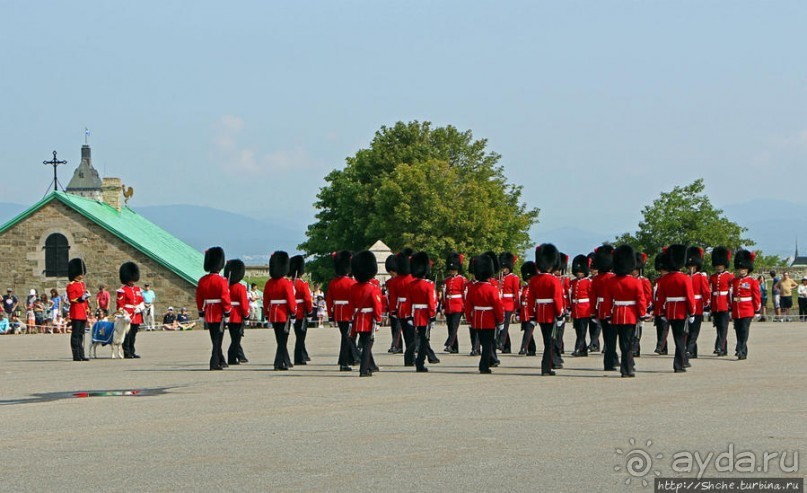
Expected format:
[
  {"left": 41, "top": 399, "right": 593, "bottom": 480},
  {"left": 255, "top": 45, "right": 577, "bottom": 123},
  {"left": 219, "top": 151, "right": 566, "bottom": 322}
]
[{"left": 0, "top": 146, "right": 204, "bottom": 315}]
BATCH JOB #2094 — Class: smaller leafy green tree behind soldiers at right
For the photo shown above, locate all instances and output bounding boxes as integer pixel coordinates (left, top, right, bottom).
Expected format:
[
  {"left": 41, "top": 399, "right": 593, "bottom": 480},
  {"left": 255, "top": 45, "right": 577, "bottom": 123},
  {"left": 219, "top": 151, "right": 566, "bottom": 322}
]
[{"left": 615, "top": 178, "right": 754, "bottom": 267}]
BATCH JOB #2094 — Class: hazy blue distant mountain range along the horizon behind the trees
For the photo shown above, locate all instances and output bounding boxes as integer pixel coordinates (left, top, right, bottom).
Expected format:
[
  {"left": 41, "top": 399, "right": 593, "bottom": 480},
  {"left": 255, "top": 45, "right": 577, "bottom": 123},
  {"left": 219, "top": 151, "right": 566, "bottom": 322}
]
[{"left": 0, "top": 199, "right": 807, "bottom": 265}]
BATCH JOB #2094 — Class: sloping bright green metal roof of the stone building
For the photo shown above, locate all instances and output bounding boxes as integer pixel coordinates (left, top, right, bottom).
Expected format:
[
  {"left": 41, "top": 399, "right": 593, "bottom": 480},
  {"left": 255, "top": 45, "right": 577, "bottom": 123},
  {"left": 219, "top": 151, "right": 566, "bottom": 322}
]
[{"left": 0, "top": 192, "right": 205, "bottom": 286}]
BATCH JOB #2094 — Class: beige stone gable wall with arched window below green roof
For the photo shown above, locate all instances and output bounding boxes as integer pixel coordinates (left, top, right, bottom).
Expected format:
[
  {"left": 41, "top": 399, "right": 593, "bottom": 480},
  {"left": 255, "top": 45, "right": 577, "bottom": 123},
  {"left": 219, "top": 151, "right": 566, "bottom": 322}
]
[{"left": 0, "top": 200, "right": 196, "bottom": 316}]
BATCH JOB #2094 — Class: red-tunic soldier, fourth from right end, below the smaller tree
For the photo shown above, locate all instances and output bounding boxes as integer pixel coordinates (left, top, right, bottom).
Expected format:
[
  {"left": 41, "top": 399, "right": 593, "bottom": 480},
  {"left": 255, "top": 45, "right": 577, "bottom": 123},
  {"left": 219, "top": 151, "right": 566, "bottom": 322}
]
[{"left": 656, "top": 245, "right": 695, "bottom": 373}]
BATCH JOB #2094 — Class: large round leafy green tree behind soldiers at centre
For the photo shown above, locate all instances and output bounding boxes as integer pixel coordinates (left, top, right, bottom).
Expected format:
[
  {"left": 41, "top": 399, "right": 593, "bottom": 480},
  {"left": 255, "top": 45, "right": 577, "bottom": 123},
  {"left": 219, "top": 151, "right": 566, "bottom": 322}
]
[{"left": 300, "top": 121, "right": 538, "bottom": 280}]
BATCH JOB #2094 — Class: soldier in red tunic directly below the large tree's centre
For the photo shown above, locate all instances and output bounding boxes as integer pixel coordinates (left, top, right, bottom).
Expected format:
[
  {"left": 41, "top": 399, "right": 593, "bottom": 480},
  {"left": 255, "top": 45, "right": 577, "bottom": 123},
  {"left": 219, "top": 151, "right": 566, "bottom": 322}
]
[{"left": 406, "top": 252, "right": 439, "bottom": 373}]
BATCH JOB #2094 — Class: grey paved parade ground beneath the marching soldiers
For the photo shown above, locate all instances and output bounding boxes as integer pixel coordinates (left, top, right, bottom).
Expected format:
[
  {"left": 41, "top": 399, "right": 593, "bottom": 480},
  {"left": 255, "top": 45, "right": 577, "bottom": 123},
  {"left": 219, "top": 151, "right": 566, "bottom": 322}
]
[{"left": 0, "top": 322, "right": 807, "bottom": 492}]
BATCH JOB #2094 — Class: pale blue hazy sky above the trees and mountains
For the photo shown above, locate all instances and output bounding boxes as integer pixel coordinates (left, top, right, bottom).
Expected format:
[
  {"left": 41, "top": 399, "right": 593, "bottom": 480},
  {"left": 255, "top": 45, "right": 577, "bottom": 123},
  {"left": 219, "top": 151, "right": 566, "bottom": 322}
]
[{"left": 0, "top": 0, "right": 807, "bottom": 241}]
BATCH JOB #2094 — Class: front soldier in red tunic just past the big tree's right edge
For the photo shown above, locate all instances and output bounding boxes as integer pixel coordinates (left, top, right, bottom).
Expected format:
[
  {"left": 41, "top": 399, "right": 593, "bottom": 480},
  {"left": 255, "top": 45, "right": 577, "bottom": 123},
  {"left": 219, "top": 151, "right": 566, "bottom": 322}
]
[{"left": 527, "top": 243, "right": 565, "bottom": 376}]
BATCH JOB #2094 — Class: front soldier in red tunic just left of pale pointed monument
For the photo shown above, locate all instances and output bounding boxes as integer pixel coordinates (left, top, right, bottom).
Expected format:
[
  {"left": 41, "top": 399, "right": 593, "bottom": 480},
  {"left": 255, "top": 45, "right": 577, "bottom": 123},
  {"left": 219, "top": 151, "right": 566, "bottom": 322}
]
[{"left": 348, "top": 250, "right": 381, "bottom": 377}]
